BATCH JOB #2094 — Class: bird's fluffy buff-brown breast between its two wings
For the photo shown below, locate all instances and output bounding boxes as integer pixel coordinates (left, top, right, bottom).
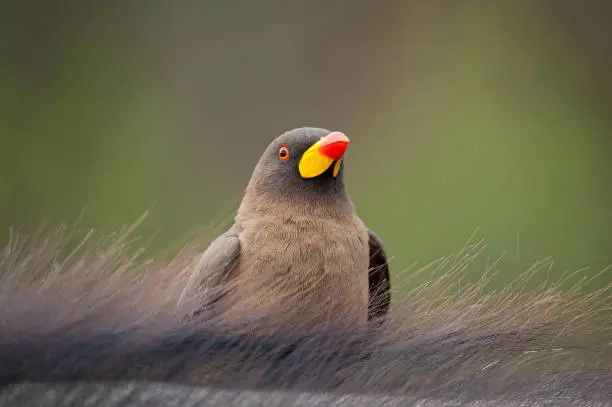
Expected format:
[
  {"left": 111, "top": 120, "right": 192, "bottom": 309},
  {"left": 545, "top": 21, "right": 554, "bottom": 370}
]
[{"left": 233, "top": 219, "right": 369, "bottom": 323}]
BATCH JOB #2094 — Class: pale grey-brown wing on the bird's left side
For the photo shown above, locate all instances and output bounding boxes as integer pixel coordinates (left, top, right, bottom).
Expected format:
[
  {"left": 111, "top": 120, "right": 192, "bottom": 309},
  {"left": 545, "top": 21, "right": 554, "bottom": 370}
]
[{"left": 179, "top": 229, "right": 240, "bottom": 303}]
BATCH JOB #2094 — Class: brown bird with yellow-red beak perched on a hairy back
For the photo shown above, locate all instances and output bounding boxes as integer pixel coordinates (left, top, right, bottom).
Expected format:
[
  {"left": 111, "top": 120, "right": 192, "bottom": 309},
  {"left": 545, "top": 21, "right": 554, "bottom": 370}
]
[{"left": 188, "top": 127, "right": 391, "bottom": 329}]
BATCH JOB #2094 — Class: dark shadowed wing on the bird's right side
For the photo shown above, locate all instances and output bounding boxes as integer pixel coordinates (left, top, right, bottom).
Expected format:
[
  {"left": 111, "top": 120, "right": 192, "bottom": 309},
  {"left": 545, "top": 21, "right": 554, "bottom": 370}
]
[{"left": 368, "top": 230, "right": 391, "bottom": 321}]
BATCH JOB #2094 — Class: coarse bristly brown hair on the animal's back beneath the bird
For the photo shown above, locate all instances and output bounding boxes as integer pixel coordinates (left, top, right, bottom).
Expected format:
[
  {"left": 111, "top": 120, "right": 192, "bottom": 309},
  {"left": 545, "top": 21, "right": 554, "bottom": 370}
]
[{"left": 0, "top": 215, "right": 612, "bottom": 405}]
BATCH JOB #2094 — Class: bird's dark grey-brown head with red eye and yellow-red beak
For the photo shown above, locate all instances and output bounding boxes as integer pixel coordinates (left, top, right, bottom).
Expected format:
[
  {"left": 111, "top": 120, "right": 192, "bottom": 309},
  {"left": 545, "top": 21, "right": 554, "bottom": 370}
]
[{"left": 241, "top": 127, "right": 349, "bottom": 210}]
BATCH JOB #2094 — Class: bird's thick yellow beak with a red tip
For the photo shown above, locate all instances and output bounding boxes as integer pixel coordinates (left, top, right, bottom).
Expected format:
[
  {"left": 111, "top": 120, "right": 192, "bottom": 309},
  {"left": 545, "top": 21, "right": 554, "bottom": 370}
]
[{"left": 298, "top": 131, "right": 349, "bottom": 178}]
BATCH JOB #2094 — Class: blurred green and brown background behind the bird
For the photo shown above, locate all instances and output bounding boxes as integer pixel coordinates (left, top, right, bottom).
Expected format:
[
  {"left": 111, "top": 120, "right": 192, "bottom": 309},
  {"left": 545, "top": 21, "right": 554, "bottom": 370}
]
[{"left": 0, "top": 0, "right": 612, "bottom": 296}]
